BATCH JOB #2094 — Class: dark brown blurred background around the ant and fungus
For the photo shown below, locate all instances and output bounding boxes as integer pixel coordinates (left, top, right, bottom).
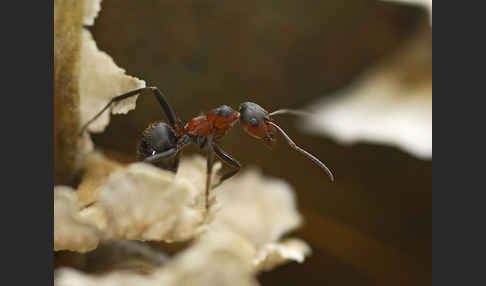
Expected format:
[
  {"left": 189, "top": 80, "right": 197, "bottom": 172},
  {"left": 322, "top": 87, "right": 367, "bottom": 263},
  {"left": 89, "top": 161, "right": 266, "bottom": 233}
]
[{"left": 91, "top": 0, "right": 432, "bottom": 285}]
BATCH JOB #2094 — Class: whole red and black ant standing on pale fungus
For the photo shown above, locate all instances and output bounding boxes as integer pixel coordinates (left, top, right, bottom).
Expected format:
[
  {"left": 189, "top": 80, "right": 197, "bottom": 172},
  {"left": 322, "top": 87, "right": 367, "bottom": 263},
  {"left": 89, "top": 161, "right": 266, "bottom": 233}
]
[{"left": 80, "top": 87, "right": 334, "bottom": 210}]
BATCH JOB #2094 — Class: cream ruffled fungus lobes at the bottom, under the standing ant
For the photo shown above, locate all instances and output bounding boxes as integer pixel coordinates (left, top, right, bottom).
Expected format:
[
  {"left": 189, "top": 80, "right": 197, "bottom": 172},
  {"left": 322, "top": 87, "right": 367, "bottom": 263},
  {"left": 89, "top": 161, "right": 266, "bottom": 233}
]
[{"left": 54, "top": 154, "right": 310, "bottom": 285}]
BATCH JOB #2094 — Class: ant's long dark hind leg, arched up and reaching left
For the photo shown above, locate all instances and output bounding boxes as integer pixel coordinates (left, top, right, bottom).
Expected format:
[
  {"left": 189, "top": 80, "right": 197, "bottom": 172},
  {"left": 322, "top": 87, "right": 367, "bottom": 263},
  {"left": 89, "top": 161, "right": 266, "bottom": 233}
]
[{"left": 79, "top": 87, "right": 177, "bottom": 135}]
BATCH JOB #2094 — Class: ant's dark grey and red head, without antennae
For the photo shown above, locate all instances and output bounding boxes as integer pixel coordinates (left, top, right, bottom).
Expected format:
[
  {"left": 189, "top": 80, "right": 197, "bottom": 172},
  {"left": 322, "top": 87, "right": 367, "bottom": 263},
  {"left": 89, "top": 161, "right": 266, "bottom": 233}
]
[{"left": 239, "top": 102, "right": 275, "bottom": 148}]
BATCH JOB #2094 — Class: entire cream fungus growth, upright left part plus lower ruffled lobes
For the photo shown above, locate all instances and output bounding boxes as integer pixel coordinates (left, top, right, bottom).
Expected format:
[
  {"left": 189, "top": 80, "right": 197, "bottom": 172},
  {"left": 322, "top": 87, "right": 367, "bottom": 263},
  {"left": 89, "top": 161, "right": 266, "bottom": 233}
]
[{"left": 54, "top": 0, "right": 310, "bottom": 285}]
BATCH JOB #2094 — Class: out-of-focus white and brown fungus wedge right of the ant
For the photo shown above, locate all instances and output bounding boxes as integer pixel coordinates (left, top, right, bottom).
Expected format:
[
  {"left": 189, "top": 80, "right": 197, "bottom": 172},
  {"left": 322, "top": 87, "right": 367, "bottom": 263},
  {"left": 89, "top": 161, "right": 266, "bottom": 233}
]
[{"left": 301, "top": 25, "right": 432, "bottom": 160}]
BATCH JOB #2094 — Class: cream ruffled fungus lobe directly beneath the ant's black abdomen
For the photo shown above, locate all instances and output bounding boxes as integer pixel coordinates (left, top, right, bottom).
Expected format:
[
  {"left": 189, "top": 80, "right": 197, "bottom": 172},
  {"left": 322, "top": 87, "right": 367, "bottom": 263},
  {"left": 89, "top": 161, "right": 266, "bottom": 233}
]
[{"left": 54, "top": 153, "right": 217, "bottom": 252}]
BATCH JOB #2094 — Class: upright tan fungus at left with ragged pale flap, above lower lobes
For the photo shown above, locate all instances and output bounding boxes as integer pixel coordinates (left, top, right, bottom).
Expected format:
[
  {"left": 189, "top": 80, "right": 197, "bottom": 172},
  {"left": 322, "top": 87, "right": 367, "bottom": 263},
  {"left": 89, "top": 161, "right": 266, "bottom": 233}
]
[{"left": 54, "top": 0, "right": 145, "bottom": 184}]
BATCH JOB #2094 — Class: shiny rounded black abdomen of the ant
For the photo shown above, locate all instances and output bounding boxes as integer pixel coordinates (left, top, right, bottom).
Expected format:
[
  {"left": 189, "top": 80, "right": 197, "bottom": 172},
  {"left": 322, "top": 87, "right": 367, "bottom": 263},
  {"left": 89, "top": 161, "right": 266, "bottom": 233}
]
[{"left": 138, "top": 122, "right": 178, "bottom": 159}]
